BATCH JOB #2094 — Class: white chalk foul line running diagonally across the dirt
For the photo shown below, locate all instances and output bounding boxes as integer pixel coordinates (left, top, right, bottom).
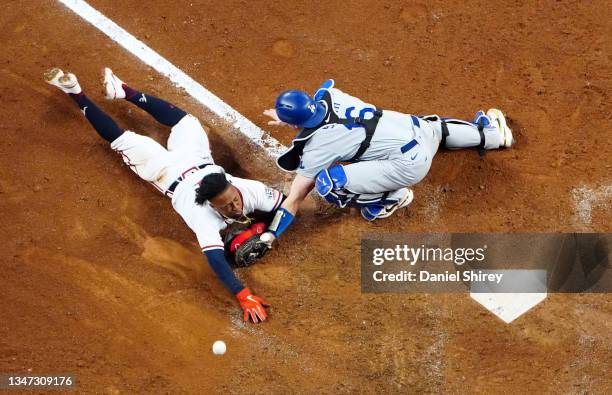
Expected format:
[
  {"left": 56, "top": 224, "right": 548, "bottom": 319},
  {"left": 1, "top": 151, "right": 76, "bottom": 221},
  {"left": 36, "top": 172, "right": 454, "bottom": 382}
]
[{"left": 58, "top": 0, "right": 286, "bottom": 158}]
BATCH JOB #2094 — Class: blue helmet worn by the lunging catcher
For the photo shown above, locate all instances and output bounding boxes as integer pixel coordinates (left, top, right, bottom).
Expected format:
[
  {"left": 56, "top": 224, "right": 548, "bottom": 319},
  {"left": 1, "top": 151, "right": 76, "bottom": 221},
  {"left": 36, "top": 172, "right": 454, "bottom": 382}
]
[{"left": 276, "top": 90, "right": 327, "bottom": 128}]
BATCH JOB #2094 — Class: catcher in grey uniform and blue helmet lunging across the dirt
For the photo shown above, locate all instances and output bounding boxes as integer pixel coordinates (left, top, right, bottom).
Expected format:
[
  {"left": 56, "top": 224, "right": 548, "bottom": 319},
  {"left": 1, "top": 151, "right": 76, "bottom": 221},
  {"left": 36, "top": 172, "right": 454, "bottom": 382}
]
[{"left": 261, "top": 80, "right": 513, "bottom": 246}]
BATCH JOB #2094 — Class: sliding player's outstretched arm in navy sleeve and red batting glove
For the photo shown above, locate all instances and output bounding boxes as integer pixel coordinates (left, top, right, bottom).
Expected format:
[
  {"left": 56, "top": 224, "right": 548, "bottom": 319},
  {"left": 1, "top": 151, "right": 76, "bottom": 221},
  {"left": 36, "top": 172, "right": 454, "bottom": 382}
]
[{"left": 205, "top": 249, "right": 269, "bottom": 323}]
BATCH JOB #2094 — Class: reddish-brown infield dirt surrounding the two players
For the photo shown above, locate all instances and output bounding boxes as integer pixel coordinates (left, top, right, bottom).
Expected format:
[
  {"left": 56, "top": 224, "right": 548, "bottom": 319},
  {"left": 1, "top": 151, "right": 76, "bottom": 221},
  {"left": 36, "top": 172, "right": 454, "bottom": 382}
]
[{"left": 0, "top": 0, "right": 612, "bottom": 394}]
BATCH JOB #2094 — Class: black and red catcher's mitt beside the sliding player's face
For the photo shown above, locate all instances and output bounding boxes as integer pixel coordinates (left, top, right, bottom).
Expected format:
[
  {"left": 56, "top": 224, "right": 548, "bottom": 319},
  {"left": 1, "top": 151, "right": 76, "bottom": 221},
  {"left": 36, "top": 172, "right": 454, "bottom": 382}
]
[{"left": 225, "top": 222, "right": 270, "bottom": 267}]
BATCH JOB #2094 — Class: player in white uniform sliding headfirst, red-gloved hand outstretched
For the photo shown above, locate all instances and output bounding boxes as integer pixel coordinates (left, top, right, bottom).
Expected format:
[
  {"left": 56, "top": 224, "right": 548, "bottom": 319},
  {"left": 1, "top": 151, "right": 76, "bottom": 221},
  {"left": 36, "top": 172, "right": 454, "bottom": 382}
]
[{"left": 45, "top": 68, "right": 284, "bottom": 323}]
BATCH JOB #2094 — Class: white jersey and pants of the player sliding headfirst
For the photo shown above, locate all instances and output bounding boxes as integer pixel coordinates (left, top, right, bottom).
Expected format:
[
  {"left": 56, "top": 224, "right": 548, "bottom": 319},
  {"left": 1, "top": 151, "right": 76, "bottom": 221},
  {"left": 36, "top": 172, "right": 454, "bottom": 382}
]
[{"left": 111, "top": 115, "right": 282, "bottom": 251}]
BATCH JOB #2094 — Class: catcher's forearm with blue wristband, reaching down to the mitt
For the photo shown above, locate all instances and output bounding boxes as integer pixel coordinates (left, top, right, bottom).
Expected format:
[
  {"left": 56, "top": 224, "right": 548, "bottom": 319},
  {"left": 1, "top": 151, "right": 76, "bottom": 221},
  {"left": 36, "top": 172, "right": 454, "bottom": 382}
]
[{"left": 260, "top": 174, "right": 314, "bottom": 247}]
